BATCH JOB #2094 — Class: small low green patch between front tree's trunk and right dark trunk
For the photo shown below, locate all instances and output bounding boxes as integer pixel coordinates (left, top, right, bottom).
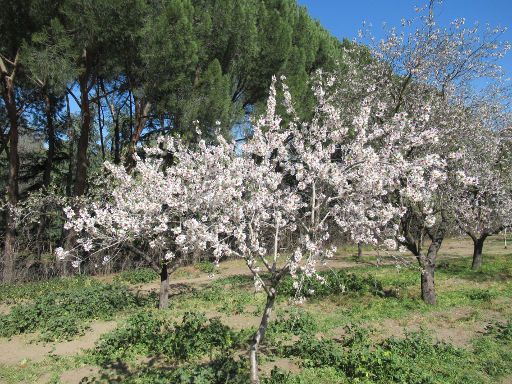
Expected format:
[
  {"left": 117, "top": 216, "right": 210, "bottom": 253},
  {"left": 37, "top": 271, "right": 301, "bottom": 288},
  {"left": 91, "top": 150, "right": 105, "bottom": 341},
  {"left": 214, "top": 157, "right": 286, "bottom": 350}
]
[{"left": 279, "top": 270, "right": 385, "bottom": 298}]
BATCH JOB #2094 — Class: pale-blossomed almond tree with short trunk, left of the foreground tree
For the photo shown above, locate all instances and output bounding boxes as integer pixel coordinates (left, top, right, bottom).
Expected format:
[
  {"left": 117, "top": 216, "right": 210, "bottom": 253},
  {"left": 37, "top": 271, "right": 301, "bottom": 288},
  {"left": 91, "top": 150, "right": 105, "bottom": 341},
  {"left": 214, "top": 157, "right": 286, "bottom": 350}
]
[{"left": 56, "top": 138, "right": 241, "bottom": 308}]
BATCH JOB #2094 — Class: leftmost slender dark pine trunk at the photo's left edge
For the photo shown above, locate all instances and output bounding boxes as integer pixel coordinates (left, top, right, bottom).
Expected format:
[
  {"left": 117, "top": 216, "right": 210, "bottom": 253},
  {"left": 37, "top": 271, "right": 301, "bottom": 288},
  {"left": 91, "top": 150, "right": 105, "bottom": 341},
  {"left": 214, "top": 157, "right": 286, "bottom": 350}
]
[{"left": 3, "top": 81, "right": 20, "bottom": 283}]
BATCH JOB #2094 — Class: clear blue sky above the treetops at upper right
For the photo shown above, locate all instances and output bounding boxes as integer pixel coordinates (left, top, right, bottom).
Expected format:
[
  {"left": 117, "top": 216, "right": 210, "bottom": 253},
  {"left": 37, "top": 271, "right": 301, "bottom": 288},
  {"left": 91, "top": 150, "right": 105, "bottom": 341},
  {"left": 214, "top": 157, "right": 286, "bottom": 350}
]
[{"left": 298, "top": 0, "right": 512, "bottom": 77}]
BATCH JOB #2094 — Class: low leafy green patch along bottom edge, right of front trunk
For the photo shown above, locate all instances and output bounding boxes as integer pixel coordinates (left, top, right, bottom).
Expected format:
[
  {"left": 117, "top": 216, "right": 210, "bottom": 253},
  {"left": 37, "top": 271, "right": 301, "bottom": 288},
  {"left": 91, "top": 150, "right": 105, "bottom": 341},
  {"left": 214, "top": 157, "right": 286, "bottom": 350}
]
[{"left": 282, "top": 328, "right": 490, "bottom": 384}]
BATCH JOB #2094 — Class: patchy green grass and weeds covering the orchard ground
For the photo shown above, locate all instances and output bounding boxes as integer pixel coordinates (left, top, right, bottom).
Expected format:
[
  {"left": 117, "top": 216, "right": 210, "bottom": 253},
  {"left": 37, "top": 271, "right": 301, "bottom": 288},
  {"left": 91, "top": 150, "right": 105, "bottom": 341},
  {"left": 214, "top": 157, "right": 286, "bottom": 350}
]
[{"left": 0, "top": 239, "right": 512, "bottom": 384}]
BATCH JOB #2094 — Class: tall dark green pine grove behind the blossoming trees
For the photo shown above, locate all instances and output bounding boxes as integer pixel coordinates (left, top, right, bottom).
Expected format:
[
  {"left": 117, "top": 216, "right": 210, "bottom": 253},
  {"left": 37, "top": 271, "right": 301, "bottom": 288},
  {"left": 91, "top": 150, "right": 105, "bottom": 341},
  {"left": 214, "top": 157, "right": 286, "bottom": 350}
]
[{"left": 0, "top": 0, "right": 356, "bottom": 277}]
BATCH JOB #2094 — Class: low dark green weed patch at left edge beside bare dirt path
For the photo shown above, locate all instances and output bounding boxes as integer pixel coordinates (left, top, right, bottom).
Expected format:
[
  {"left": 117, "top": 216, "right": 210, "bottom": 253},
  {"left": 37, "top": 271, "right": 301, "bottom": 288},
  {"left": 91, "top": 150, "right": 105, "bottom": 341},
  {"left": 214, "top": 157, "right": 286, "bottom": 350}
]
[{"left": 0, "top": 281, "right": 153, "bottom": 341}]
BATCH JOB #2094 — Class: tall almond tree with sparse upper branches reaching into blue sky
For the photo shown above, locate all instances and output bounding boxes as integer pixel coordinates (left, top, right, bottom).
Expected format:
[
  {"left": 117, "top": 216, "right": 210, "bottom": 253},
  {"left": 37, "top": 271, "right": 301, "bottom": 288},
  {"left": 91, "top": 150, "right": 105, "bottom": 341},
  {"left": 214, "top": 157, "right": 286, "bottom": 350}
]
[{"left": 345, "top": 0, "right": 510, "bottom": 304}]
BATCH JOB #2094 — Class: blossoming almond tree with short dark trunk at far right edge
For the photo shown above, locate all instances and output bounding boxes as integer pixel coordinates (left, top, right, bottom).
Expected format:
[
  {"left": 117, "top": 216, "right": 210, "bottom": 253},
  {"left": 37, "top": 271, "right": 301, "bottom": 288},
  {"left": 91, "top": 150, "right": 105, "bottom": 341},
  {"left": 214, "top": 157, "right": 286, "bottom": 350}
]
[{"left": 449, "top": 100, "right": 512, "bottom": 269}]
